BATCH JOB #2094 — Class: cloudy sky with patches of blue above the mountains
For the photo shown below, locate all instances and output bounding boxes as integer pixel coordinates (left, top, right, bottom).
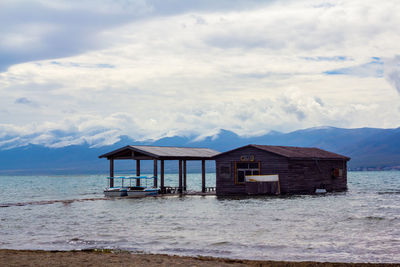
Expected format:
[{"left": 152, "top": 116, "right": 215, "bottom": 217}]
[{"left": 0, "top": 0, "right": 400, "bottom": 148}]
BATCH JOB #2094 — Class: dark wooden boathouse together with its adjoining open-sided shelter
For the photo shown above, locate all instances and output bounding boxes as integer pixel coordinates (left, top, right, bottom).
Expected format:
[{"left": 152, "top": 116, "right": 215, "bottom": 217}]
[{"left": 99, "top": 145, "right": 350, "bottom": 196}]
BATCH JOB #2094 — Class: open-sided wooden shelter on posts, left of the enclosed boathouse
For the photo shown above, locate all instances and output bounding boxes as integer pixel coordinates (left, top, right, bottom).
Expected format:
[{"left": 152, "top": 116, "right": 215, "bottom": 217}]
[{"left": 99, "top": 146, "right": 219, "bottom": 193}]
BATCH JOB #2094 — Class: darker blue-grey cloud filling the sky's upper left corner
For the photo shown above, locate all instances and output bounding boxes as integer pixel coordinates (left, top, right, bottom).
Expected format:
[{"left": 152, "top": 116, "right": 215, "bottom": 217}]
[{"left": 0, "top": 0, "right": 271, "bottom": 72}]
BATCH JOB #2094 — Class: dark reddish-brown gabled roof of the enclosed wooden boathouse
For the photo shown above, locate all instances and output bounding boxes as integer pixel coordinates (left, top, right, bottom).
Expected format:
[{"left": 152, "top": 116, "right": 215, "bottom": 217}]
[{"left": 214, "top": 144, "right": 350, "bottom": 160}]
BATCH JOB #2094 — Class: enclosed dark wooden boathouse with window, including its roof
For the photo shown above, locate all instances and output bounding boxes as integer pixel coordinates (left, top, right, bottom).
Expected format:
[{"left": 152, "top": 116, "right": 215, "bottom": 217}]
[{"left": 213, "top": 145, "right": 350, "bottom": 196}]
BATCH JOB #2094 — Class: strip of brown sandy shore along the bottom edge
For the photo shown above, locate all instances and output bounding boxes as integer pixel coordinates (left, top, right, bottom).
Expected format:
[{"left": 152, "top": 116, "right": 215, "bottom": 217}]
[{"left": 0, "top": 249, "right": 400, "bottom": 267}]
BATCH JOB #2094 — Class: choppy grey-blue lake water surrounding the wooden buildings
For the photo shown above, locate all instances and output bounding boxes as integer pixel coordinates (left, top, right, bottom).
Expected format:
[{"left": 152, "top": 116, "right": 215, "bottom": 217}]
[{"left": 0, "top": 172, "right": 400, "bottom": 262}]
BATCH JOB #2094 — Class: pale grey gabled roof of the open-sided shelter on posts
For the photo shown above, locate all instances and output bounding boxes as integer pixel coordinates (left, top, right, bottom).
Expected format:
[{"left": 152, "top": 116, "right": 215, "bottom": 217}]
[{"left": 99, "top": 146, "right": 219, "bottom": 160}]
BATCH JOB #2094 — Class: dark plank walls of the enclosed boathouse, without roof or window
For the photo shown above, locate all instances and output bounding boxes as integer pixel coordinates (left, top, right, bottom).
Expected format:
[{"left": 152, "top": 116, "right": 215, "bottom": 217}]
[{"left": 215, "top": 147, "right": 347, "bottom": 196}]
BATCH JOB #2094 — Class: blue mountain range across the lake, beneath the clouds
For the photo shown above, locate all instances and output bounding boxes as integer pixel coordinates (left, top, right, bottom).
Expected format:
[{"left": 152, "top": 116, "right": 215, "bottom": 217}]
[{"left": 0, "top": 127, "right": 400, "bottom": 174}]
